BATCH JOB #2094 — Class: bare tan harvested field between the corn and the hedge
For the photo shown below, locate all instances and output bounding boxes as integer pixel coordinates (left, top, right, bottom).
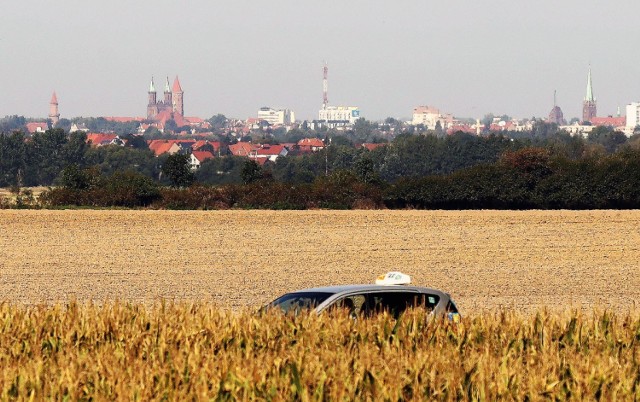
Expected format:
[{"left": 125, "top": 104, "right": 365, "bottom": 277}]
[{"left": 0, "top": 210, "right": 640, "bottom": 313}]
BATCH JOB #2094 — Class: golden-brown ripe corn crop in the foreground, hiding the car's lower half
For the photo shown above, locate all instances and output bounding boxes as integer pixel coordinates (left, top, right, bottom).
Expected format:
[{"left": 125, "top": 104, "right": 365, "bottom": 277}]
[{"left": 0, "top": 302, "right": 640, "bottom": 401}]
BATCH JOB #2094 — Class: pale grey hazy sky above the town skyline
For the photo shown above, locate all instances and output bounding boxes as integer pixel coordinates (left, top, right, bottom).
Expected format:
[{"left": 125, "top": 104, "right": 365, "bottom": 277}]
[{"left": 0, "top": 0, "right": 640, "bottom": 120}]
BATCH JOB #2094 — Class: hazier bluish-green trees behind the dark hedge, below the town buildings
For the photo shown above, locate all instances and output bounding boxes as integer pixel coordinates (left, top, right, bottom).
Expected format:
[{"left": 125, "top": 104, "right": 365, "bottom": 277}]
[{"left": 0, "top": 126, "right": 640, "bottom": 187}]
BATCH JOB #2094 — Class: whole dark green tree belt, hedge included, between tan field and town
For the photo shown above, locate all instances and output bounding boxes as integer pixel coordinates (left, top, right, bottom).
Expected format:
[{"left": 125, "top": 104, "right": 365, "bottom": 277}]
[{"left": 0, "top": 123, "right": 640, "bottom": 209}]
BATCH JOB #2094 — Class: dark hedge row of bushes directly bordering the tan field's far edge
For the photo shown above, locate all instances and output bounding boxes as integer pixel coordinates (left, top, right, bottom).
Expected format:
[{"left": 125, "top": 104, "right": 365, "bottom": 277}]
[{"left": 28, "top": 147, "right": 640, "bottom": 209}]
